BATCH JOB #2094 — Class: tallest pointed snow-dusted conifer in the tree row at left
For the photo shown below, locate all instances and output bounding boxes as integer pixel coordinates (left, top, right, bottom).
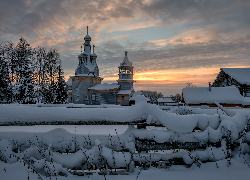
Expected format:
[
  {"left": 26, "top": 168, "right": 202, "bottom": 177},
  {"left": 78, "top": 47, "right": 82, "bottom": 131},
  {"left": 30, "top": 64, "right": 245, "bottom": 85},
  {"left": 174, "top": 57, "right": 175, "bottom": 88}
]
[{"left": 14, "top": 38, "right": 36, "bottom": 104}]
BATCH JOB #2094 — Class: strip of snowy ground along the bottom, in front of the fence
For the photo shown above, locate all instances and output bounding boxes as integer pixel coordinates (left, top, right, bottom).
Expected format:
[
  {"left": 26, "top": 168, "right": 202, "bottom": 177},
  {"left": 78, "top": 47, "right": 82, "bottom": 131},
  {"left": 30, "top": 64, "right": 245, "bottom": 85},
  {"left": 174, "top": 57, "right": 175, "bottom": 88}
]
[{"left": 0, "top": 160, "right": 250, "bottom": 180}]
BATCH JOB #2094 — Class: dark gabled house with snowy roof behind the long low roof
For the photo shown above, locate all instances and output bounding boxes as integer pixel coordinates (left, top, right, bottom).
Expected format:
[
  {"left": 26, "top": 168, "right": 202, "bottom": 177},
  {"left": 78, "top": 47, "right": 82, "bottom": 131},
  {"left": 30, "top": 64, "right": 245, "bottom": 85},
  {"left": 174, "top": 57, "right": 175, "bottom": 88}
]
[{"left": 212, "top": 68, "right": 250, "bottom": 97}]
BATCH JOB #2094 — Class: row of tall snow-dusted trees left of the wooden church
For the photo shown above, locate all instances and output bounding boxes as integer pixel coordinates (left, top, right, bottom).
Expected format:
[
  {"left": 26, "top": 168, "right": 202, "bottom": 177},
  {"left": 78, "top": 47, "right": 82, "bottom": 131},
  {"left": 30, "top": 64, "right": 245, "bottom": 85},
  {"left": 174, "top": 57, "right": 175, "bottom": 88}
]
[{"left": 0, "top": 38, "right": 67, "bottom": 104}]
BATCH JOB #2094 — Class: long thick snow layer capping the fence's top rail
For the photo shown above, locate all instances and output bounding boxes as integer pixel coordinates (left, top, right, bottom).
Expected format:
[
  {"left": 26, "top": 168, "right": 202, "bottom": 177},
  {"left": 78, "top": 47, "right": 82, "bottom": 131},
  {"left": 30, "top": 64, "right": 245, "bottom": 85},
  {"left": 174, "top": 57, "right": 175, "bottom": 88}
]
[{"left": 0, "top": 101, "right": 250, "bottom": 133}]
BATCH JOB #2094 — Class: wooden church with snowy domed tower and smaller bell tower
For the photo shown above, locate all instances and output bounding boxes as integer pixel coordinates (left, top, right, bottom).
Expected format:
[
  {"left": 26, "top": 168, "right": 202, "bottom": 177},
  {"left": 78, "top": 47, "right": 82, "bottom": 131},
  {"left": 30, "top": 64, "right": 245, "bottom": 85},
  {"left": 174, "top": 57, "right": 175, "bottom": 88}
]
[{"left": 68, "top": 27, "right": 135, "bottom": 106}]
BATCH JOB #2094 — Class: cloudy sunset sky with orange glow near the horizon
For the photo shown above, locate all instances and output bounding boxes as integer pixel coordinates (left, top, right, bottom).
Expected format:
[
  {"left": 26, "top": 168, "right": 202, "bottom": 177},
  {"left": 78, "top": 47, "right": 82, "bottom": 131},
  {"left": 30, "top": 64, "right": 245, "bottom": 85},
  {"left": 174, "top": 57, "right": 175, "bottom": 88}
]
[{"left": 0, "top": 0, "right": 250, "bottom": 96}]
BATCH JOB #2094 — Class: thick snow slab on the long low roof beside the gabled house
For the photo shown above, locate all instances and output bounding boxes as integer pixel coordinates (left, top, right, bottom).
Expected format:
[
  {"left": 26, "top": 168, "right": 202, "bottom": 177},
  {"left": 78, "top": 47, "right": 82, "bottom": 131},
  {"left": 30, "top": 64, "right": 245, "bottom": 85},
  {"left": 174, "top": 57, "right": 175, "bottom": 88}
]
[{"left": 182, "top": 87, "right": 243, "bottom": 104}]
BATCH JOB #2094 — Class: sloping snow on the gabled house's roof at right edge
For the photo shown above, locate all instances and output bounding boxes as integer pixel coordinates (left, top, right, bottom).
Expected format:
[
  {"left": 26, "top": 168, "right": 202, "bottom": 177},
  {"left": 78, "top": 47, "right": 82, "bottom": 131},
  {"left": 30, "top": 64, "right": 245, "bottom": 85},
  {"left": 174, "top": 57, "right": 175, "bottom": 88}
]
[{"left": 221, "top": 68, "right": 250, "bottom": 85}]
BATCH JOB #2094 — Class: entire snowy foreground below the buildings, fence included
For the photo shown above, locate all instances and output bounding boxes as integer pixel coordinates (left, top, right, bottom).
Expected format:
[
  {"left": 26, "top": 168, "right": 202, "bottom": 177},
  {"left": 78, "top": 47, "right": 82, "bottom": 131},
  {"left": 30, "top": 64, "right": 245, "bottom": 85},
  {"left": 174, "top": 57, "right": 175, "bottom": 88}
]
[{"left": 0, "top": 99, "right": 250, "bottom": 180}]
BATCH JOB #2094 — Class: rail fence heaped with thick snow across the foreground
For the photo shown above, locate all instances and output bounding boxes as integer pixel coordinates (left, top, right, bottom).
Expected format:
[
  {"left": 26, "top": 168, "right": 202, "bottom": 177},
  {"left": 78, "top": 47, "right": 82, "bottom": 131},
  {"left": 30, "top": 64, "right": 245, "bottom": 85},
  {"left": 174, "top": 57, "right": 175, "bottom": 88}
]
[{"left": 0, "top": 99, "right": 250, "bottom": 176}]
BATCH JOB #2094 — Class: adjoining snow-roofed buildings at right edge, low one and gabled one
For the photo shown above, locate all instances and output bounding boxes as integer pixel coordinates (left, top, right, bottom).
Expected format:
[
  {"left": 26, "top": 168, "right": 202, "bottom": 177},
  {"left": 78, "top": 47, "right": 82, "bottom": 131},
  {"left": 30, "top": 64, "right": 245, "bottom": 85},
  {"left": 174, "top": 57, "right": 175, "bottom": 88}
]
[{"left": 182, "top": 68, "right": 250, "bottom": 107}]
